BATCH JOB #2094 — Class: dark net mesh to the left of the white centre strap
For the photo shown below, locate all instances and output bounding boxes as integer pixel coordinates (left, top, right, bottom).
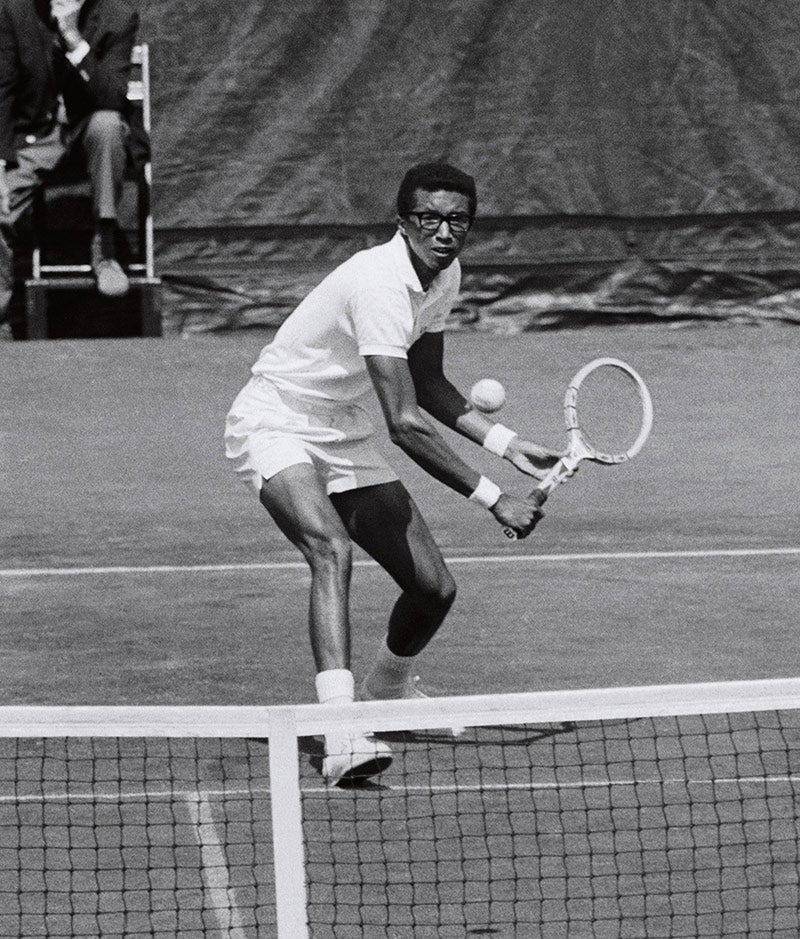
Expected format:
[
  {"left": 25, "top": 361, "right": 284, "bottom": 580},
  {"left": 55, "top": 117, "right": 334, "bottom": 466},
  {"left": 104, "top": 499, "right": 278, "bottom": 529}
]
[{"left": 0, "top": 738, "right": 275, "bottom": 939}]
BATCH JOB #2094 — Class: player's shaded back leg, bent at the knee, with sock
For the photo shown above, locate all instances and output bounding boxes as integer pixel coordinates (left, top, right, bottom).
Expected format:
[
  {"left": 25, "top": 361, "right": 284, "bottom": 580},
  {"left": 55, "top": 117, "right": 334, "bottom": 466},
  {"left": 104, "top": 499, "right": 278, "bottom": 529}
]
[{"left": 332, "top": 482, "right": 456, "bottom": 697}]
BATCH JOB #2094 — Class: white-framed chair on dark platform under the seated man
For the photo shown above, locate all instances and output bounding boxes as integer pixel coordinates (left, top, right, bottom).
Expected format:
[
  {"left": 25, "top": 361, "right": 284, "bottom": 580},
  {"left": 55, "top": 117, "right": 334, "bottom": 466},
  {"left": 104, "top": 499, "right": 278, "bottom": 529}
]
[{"left": 25, "top": 43, "right": 161, "bottom": 339}]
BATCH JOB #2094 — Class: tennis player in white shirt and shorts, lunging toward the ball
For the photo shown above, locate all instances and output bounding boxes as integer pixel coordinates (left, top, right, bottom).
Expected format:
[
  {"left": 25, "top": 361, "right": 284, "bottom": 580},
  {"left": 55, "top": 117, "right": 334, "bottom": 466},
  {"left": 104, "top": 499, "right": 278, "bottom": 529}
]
[{"left": 225, "top": 163, "right": 559, "bottom": 785}]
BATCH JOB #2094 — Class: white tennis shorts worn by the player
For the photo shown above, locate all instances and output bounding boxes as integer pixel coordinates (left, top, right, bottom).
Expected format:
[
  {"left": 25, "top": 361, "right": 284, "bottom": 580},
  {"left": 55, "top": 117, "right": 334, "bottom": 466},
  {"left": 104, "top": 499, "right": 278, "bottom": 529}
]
[{"left": 225, "top": 375, "right": 398, "bottom": 494}]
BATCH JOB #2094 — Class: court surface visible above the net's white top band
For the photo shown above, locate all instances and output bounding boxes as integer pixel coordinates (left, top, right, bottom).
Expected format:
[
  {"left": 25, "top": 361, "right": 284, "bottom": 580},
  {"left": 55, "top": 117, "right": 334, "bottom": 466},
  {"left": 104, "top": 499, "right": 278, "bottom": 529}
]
[{"left": 0, "top": 327, "right": 800, "bottom": 705}]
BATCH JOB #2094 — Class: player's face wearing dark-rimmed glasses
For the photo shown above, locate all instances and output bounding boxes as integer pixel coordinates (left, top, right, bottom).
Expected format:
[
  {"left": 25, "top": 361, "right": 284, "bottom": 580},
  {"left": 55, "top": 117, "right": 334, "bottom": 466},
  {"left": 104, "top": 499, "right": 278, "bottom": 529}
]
[{"left": 398, "top": 189, "right": 472, "bottom": 286}]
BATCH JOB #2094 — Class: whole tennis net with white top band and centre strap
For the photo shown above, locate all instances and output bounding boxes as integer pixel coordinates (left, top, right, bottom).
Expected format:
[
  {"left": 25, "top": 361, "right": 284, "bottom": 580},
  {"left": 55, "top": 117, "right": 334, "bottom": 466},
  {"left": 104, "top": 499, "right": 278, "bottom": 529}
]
[{"left": 0, "top": 679, "right": 800, "bottom": 939}]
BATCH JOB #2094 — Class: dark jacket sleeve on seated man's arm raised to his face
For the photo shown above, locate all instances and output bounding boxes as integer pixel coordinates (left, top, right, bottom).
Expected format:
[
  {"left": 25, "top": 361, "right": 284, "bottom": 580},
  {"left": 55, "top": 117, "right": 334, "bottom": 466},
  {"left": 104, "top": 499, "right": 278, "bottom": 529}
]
[{"left": 67, "top": 11, "right": 139, "bottom": 113}]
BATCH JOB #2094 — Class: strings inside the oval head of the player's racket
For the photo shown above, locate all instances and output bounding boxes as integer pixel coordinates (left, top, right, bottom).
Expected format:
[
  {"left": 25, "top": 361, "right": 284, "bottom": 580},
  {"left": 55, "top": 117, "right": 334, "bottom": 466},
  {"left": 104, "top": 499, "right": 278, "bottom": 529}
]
[{"left": 575, "top": 366, "right": 643, "bottom": 455}]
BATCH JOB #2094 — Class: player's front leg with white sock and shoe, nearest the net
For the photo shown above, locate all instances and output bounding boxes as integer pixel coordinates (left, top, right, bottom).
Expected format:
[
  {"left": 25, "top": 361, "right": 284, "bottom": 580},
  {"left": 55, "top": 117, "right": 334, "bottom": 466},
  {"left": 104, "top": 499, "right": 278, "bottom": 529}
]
[{"left": 261, "top": 463, "right": 391, "bottom": 785}]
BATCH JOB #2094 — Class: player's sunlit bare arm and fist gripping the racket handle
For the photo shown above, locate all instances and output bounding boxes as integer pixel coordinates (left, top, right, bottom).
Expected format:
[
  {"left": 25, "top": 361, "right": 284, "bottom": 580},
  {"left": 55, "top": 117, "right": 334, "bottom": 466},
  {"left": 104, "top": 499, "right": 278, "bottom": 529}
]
[{"left": 366, "top": 355, "right": 542, "bottom": 537}]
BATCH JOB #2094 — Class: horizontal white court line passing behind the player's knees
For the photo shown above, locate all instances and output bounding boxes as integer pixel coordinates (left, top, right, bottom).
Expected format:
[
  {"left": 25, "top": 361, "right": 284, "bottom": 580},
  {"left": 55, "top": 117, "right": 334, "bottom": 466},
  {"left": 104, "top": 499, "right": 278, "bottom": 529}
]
[{"left": 0, "top": 548, "right": 800, "bottom": 578}]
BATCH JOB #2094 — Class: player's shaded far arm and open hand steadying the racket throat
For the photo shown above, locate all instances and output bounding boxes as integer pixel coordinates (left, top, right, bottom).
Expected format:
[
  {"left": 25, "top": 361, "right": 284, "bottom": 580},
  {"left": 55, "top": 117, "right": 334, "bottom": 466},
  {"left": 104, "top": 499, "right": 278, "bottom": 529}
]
[{"left": 408, "top": 333, "right": 564, "bottom": 479}]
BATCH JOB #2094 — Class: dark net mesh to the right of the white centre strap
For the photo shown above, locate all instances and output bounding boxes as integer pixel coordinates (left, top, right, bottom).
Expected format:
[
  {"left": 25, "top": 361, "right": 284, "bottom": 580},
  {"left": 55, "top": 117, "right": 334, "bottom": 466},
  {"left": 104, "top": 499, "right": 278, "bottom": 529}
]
[{"left": 304, "top": 712, "right": 800, "bottom": 939}]
